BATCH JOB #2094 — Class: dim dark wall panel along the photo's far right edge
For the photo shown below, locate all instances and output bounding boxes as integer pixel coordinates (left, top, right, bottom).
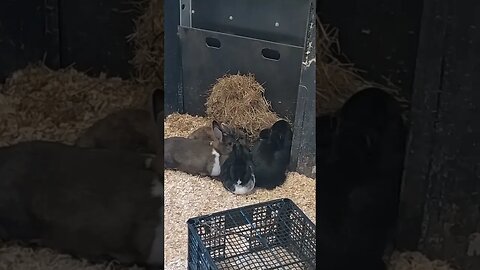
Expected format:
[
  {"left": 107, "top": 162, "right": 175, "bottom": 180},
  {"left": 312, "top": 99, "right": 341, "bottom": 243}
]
[{"left": 420, "top": 0, "right": 480, "bottom": 270}]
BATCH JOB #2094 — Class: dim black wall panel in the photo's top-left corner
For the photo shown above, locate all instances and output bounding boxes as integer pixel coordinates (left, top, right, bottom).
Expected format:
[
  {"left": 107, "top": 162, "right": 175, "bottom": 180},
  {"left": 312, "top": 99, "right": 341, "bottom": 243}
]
[{"left": 0, "top": 0, "right": 58, "bottom": 82}]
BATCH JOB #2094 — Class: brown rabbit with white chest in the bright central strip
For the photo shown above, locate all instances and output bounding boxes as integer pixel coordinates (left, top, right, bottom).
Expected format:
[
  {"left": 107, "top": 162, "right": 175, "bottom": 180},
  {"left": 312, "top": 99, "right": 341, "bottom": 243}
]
[{"left": 164, "top": 121, "right": 235, "bottom": 176}]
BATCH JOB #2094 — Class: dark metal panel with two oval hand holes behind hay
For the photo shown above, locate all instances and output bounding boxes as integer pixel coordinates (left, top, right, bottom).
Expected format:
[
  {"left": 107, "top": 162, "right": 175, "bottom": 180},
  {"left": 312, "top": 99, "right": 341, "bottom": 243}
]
[{"left": 179, "top": 26, "right": 303, "bottom": 121}]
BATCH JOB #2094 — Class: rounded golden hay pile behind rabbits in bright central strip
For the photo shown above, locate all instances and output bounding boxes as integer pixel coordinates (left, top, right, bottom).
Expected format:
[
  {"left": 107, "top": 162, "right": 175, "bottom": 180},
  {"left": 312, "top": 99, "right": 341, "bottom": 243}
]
[{"left": 205, "top": 74, "right": 280, "bottom": 139}]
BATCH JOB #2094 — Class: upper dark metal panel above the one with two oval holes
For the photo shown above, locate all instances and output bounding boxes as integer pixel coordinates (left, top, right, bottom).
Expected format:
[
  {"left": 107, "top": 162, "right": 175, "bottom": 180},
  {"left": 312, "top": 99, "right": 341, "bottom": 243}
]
[{"left": 180, "top": 0, "right": 311, "bottom": 46}]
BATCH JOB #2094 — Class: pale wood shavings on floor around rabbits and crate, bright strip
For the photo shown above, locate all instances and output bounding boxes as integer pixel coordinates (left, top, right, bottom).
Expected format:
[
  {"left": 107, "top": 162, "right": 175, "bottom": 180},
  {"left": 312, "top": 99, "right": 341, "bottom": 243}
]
[{"left": 164, "top": 114, "right": 315, "bottom": 270}]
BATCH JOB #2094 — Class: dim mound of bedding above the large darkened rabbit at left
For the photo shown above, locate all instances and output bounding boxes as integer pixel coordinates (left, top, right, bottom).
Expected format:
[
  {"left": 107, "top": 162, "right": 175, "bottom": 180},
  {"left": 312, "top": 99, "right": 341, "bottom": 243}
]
[{"left": 0, "top": 65, "right": 149, "bottom": 145}]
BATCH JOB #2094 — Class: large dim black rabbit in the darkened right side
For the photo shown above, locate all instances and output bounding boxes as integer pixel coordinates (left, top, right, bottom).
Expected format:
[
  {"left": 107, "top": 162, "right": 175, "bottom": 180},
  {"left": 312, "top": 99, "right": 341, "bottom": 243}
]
[{"left": 316, "top": 88, "right": 406, "bottom": 270}]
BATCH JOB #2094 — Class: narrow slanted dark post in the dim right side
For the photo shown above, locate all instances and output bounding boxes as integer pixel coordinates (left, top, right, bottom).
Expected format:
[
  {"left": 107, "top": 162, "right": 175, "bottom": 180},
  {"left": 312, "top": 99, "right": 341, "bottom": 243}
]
[{"left": 398, "top": 0, "right": 446, "bottom": 249}]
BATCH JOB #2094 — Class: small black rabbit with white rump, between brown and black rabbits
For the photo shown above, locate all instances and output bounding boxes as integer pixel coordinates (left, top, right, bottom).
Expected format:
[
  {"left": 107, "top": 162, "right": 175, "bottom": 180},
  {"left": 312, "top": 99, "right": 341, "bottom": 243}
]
[{"left": 219, "top": 143, "right": 255, "bottom": 195}]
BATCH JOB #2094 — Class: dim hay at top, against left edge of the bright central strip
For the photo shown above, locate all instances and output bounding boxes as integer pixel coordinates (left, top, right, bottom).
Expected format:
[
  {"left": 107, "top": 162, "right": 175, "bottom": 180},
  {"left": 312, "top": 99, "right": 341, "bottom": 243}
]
[{"left": 128, "top": 0, "right": 164, "bottom": 88}]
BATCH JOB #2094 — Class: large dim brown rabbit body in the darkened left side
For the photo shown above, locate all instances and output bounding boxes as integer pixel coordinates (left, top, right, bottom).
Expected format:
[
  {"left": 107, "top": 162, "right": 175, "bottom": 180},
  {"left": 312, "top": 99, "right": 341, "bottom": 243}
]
[{"left": 0, "top": 141, "right": 164, "bottom": 269}]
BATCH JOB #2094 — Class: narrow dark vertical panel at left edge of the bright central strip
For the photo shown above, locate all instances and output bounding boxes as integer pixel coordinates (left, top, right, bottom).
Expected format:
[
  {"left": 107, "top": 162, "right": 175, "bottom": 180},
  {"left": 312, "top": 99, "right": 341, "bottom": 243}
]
[{"left": 164, "top": 1, "right": 183, "bottom": 116}]
